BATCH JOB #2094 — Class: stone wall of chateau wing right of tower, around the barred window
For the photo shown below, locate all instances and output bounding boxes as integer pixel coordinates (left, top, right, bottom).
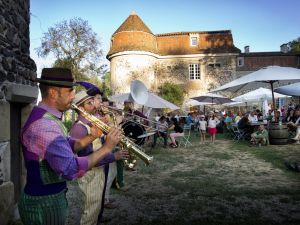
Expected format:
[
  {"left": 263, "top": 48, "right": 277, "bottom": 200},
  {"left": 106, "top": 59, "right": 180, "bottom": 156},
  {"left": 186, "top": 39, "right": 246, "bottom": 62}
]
[{"left": 155, "top": 55, "right": 236, "bottom": 99}]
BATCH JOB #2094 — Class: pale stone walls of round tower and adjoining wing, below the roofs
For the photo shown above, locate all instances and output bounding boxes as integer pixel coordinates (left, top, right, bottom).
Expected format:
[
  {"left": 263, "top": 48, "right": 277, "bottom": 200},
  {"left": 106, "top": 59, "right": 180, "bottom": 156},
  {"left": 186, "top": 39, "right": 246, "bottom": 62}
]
[{"left": 110, "top": 52, "right": 237, "bottom": 99}]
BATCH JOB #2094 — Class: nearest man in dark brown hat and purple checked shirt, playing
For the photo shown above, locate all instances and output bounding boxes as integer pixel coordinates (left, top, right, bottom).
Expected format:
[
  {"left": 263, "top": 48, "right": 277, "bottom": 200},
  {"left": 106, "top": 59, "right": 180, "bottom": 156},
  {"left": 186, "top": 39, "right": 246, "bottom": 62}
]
[{"left": 19, "top": 68, "right": 122, "bottom": 225}]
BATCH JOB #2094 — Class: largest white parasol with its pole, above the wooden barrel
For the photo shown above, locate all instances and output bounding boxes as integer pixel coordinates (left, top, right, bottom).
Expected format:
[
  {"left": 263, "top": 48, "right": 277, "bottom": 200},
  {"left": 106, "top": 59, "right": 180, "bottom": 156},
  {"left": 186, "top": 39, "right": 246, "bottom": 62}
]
[{"left": 213, "top": 66, "right": 300, "bottom": 109}]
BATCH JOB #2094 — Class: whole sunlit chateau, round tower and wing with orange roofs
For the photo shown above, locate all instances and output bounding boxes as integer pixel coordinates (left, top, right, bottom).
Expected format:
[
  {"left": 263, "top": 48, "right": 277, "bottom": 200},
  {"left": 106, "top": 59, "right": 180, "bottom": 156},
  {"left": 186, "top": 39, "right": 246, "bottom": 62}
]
[{"left": 107, "top": 13, "right": 240, "bottom": 98}]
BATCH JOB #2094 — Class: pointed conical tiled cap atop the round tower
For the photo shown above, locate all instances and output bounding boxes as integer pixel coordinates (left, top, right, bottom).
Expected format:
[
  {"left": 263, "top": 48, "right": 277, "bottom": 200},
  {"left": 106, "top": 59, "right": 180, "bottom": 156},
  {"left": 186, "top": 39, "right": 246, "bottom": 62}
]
[{"left": 113, "top": 12, "right": 153, "bottom": 35}]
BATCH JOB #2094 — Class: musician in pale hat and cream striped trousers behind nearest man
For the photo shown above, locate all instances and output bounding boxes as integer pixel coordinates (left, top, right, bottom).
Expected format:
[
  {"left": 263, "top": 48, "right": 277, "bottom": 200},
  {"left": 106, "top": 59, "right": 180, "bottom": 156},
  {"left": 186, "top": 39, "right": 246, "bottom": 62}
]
[{"left": 70, "top": 91, "right": 128, "bottom": 224}]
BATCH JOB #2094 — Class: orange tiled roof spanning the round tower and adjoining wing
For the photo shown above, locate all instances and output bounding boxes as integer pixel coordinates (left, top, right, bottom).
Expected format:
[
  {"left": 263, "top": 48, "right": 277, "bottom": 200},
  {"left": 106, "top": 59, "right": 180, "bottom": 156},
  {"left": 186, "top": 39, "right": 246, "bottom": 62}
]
[{"left": 107, "top": 13, "right": 241, "bottom": 58}]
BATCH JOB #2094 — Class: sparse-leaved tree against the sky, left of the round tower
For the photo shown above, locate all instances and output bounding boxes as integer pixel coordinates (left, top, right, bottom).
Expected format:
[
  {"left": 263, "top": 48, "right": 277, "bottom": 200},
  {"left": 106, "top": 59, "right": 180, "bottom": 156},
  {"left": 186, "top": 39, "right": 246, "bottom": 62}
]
[{"left": 36, "top": 18, "right": 104, "bottom": 80}]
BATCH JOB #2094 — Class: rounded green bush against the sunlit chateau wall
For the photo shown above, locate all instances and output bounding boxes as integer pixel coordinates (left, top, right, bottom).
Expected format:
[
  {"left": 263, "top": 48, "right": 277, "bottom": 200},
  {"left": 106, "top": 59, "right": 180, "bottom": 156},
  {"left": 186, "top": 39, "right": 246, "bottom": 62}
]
[{"left": 158, "top": 82, "right": 184, "bottom": 106}]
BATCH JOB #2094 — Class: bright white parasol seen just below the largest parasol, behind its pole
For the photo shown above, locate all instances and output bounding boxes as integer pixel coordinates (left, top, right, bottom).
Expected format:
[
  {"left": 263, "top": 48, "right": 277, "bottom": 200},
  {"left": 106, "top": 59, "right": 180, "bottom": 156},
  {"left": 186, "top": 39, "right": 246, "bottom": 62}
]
[{"left": 232, "top": 88, "right": 288, "bottom": 102}]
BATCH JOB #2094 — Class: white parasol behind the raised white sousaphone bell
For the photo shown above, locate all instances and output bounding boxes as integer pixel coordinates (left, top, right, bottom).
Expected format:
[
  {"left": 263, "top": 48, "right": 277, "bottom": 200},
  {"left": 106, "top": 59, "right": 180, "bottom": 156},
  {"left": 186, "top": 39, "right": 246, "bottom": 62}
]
[{"left": 109, "top": 92, "right": 179, "bottom": 110}]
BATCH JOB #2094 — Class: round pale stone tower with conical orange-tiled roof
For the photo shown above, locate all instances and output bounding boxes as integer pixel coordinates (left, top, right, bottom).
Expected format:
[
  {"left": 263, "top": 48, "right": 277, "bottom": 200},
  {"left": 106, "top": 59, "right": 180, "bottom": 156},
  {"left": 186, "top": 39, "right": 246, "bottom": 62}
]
[{"left": 107, "top": 12, "right": 157, "bottom": 94}]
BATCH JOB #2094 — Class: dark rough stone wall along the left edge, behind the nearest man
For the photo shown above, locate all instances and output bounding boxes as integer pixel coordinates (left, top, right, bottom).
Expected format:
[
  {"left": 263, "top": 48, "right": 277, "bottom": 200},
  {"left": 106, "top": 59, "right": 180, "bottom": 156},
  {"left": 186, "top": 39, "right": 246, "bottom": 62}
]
[{"left": 0, "top": 0, "right": 38, "bottom": 225}]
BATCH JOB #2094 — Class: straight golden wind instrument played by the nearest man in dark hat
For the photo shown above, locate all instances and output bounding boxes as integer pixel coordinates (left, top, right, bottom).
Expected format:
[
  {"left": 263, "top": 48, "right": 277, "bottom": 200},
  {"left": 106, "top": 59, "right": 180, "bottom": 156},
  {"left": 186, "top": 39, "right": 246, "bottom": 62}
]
[{"left": 71, "top": 103, "right": 153, "bottom": 165}]
